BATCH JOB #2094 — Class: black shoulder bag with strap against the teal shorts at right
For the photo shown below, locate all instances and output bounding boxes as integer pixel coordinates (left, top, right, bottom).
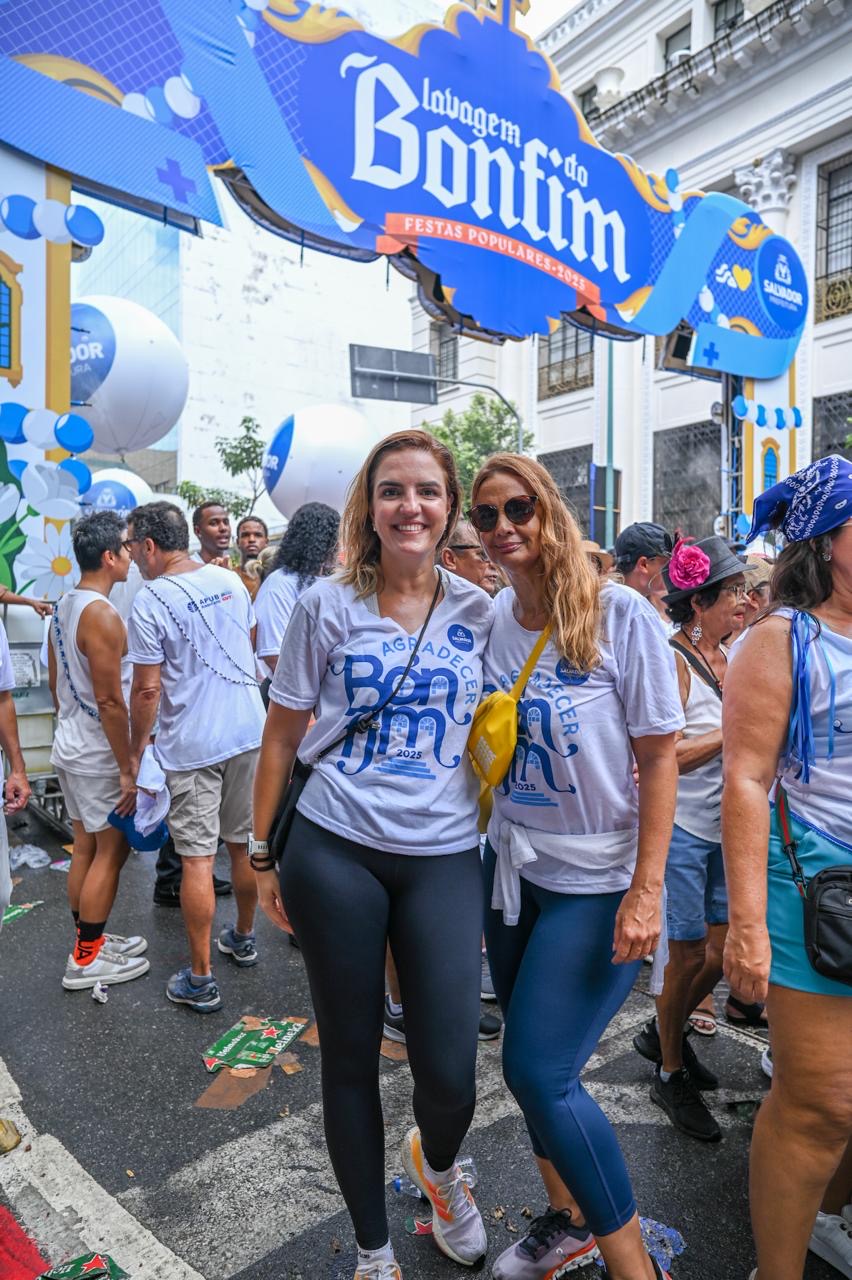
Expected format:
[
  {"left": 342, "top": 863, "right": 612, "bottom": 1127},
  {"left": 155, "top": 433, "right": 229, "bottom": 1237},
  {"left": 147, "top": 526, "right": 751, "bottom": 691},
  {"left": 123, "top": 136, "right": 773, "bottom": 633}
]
[{"left": 775, "top": 782, "right": 852, "bottom": 987}]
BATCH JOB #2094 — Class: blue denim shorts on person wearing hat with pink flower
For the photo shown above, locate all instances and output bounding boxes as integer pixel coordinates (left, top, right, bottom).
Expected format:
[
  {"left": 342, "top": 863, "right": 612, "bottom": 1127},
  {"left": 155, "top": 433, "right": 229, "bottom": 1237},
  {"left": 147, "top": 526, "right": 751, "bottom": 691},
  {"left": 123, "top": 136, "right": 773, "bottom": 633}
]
[{"left": 665, "top": 823, "right": 728, "bottom": 942}]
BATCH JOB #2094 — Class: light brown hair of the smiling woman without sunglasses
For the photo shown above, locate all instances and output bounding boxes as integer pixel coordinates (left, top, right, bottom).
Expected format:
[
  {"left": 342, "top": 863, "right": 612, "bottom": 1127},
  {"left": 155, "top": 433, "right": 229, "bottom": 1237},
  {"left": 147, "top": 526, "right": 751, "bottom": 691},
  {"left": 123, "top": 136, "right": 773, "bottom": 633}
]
[{"left": 338, "top": 429, "right": 462, "bottom": 599}]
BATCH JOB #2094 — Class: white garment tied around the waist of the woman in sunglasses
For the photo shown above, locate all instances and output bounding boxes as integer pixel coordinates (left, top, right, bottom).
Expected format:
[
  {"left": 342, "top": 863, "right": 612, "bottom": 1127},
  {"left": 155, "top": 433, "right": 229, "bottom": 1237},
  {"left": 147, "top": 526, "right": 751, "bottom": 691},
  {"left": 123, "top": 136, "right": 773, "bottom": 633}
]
[{"left": 487, "top": 814, "right": 669, "bottom": 996}]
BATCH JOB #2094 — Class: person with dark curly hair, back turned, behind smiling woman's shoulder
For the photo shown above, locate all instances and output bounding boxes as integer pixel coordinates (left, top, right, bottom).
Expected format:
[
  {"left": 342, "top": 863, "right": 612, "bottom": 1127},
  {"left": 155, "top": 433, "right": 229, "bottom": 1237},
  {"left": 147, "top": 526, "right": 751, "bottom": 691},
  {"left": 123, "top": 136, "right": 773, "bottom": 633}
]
[{"left": 255, "top": 502, "right": 340, "bottom": 675}]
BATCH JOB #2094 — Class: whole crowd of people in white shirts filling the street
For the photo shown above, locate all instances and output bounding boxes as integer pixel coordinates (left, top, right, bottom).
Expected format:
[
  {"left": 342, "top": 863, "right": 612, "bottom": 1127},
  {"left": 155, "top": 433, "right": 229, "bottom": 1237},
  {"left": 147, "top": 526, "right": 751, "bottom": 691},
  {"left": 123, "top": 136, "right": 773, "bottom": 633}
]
[{"left": 0, "top": 440, "right": 852, "bottom": 1280}]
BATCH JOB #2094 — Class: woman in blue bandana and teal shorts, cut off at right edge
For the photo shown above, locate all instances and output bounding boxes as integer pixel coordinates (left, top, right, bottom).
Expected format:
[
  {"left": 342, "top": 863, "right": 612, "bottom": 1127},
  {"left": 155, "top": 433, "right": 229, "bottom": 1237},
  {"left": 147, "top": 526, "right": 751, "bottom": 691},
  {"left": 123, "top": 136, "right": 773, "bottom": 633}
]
[{"left": 722, "top": 454, "right": 852, "bottom": 1280}]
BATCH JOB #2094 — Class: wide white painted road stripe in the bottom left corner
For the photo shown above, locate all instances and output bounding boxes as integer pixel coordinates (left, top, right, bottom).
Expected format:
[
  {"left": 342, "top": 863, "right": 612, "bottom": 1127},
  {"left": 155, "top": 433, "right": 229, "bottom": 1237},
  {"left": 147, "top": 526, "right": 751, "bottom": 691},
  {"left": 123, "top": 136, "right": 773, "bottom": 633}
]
[{"left": 0, "top": 1059, "right": 205, "bottom": 1280}]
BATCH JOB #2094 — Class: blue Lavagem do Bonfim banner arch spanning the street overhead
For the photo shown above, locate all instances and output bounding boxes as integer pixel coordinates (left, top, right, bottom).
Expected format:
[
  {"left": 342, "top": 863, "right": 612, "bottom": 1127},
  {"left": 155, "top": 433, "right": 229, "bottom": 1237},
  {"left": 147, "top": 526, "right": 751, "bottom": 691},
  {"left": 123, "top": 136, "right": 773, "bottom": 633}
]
[{"left": 0, "top": 0, "right": 809, "bottom": 378}]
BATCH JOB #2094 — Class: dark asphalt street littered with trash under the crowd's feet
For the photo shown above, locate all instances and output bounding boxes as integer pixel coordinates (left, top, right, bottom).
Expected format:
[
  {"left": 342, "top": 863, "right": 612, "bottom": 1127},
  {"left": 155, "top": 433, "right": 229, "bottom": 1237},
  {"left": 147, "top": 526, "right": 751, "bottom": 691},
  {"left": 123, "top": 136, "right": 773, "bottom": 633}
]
[{"left": 0, "top": 819, "right": 838, "bottom": 1280}]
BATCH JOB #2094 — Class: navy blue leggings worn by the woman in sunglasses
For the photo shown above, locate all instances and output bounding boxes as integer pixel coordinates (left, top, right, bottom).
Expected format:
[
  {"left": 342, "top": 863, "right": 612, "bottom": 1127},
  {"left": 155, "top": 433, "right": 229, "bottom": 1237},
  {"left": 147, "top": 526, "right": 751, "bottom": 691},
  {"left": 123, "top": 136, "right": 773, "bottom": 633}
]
[{"left": 485, "top": 845, "right": 641, "bottom": 1235}]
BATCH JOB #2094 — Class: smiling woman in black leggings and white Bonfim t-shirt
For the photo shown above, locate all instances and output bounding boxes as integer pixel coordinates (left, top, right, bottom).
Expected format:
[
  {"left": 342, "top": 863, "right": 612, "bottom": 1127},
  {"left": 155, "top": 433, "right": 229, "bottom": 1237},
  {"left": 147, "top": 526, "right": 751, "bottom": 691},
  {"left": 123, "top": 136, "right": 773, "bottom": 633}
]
[{"left": 251, "top": 431, "right": 494, "bottom": 1280}]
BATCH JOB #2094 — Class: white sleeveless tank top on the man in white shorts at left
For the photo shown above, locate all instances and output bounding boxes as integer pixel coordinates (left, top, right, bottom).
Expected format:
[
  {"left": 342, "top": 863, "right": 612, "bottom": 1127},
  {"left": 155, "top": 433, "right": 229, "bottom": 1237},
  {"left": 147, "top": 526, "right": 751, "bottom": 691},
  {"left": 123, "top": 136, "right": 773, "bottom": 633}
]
[{"left": 50, "top": 589, "right": 133, "bottom": 777}]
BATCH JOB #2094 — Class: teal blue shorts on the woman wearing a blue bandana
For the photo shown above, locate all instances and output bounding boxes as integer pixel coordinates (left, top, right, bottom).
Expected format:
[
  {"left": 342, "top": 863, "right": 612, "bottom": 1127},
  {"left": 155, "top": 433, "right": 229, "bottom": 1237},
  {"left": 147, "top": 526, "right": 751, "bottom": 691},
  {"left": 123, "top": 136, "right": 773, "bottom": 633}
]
[{"left": 766, "top": 808, "right": 852, "bottom": 997}]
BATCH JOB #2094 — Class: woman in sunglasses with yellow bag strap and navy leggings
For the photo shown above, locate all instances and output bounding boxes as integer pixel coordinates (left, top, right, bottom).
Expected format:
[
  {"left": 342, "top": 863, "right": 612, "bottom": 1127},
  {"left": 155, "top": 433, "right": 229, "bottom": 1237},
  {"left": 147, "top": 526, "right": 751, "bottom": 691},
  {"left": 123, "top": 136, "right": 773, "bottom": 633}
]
[{"left": 468, "top": 453, "right": 683, "bottom": 1280}]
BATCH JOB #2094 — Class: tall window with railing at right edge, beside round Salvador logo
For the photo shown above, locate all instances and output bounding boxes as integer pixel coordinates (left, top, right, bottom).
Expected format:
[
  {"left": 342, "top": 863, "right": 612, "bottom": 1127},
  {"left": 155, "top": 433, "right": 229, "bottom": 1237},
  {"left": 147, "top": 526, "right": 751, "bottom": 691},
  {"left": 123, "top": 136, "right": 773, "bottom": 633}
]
[{"left": 814, "top": 152, "right": 852, "bottom": 321}]
